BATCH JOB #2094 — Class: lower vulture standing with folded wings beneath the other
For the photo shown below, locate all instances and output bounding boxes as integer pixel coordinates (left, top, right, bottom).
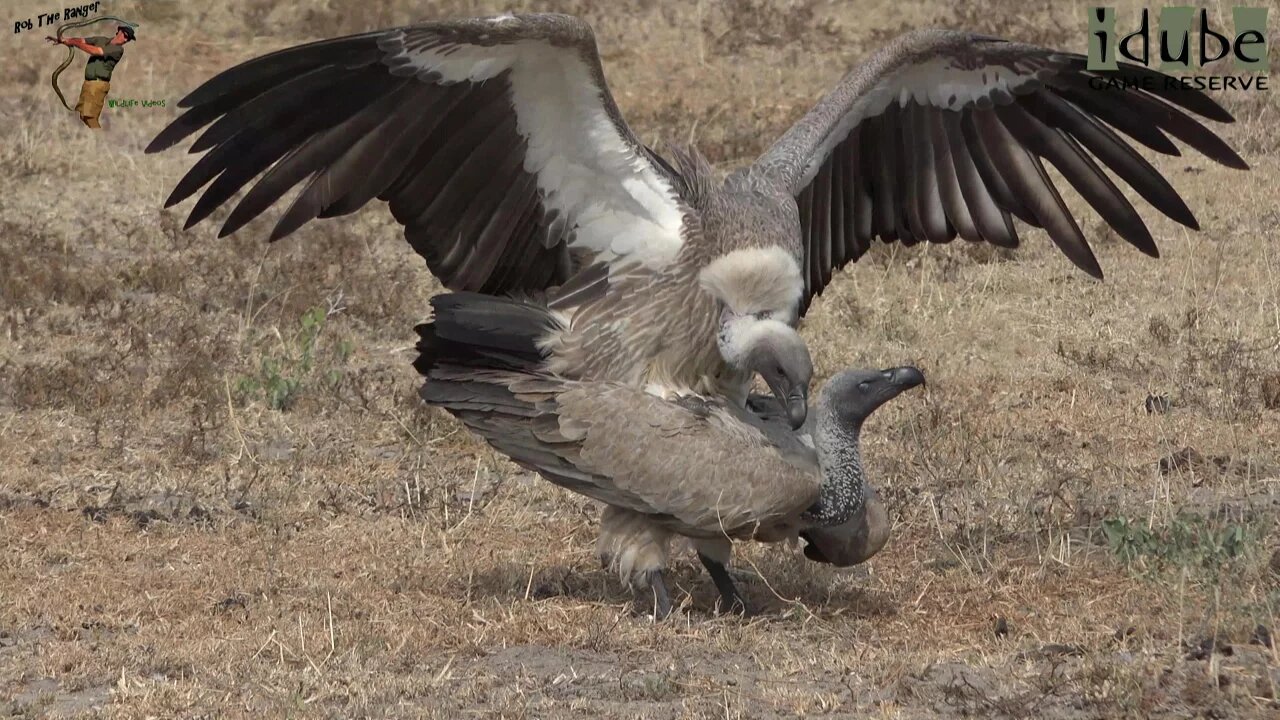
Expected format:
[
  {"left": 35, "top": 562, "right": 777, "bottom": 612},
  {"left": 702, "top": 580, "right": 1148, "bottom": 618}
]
[{"left": 416, "top": 288, "right": 924, "bottom": 619}]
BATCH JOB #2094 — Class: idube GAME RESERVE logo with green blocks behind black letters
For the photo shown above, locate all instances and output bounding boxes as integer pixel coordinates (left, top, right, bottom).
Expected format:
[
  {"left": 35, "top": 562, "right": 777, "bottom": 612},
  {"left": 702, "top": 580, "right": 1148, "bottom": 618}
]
[{"left": 1088, "top": 6, "right": 1267, "bottom": 90}]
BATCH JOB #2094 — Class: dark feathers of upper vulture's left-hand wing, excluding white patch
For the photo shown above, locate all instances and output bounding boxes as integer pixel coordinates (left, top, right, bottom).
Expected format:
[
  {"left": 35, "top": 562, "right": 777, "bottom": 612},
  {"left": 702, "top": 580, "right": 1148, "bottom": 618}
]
[{"left": 147, "top": 15, "right": 680, "bottom": 292}]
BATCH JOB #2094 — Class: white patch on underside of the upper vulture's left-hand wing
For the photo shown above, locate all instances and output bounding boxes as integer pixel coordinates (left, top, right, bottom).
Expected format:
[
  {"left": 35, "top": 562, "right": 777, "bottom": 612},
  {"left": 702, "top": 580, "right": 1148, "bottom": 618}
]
[{"left": 388, "top": 32, "right": 684, "bottom": 269}]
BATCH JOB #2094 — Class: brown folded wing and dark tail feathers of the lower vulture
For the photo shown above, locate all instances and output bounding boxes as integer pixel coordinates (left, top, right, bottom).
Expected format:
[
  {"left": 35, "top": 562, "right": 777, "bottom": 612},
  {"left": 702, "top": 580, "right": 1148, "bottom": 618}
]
[{"left": 417, "top": 296, "right": 820, "bottom": 537}]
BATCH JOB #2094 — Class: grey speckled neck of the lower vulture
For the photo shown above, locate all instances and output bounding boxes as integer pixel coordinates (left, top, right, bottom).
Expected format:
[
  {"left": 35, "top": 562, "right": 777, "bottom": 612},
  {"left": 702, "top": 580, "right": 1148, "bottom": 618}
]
[{"left": 805, "top": 411, "right": 867, "bottom": 528}]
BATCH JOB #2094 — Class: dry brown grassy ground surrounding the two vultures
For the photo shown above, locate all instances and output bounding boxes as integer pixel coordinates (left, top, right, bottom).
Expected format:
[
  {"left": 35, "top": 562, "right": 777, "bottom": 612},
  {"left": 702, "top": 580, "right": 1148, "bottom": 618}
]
[{"left": 0, "top": 0, "right": 1280, "bottom": 719}]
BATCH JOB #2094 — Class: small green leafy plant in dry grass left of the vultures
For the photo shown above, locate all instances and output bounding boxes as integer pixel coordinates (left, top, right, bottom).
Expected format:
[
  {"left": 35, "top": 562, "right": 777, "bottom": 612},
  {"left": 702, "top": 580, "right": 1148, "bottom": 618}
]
[{"left": 236, "top": 301, "right": 355, "bottom": 411}]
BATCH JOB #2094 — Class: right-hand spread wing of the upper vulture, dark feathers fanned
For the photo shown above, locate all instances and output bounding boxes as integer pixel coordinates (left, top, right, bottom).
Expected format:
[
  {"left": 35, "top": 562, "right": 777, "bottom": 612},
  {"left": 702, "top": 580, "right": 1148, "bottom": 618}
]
[{"left": 755, "top": 31, "right": 1248, "bottom": 306}]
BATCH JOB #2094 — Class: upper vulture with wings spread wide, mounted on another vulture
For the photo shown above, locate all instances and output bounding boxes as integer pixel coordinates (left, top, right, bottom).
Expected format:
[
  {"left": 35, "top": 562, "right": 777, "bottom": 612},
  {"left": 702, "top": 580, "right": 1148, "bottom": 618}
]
[{"left": 147, "top": 14, "right": 1248, "bottom": 604}]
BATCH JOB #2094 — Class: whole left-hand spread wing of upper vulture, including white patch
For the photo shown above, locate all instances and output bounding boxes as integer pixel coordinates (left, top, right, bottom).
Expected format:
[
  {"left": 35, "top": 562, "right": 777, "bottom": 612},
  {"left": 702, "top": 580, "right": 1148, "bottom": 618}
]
[{"left": 147, "top": 15, "right": 684, "bottom": 293}]
